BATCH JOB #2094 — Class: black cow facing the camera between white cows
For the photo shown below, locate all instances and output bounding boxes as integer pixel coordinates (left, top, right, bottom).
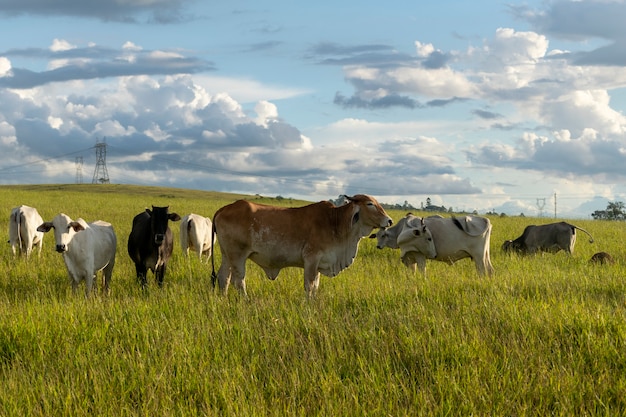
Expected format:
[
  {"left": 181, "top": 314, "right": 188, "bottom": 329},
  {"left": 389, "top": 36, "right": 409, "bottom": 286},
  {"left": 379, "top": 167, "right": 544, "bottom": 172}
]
[{"left": 128, "top": 206, "right": 180, "bottom": 288}]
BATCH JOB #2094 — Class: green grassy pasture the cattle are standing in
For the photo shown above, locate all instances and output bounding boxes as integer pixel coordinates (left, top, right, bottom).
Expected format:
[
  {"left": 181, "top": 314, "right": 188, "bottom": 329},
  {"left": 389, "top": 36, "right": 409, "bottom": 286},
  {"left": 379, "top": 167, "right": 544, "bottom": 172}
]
[{"left": 0, "top": 185, "right": 626, "bottom": 416}]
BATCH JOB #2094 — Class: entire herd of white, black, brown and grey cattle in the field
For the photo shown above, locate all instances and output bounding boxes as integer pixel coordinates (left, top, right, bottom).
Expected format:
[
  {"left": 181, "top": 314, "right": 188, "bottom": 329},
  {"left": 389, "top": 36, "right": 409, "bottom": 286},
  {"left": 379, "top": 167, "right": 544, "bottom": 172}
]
[{"left": 9, "top": 194, "right": 613, "bottom": 296}]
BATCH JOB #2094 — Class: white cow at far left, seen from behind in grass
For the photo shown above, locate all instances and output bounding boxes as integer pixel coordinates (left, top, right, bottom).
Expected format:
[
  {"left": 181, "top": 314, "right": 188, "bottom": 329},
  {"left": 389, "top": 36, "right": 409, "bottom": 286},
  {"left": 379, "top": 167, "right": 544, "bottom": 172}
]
[{"left": 9, "top": 206, "right": 44, "bottom": 258}]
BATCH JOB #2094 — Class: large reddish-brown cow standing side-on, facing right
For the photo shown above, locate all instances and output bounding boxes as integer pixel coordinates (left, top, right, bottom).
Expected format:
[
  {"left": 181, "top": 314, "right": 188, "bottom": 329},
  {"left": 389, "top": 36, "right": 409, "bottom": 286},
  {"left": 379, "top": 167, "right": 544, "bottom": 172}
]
[{"left": 211, "top": 194, "right": 392, "bottom": 297}]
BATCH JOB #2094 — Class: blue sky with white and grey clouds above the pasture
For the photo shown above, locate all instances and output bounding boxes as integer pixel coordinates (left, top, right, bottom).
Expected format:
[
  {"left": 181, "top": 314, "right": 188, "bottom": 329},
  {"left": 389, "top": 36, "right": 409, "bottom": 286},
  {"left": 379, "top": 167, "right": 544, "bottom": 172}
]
[{"left": 0, "top": 0, "right": 626, "bottom": 218}]
